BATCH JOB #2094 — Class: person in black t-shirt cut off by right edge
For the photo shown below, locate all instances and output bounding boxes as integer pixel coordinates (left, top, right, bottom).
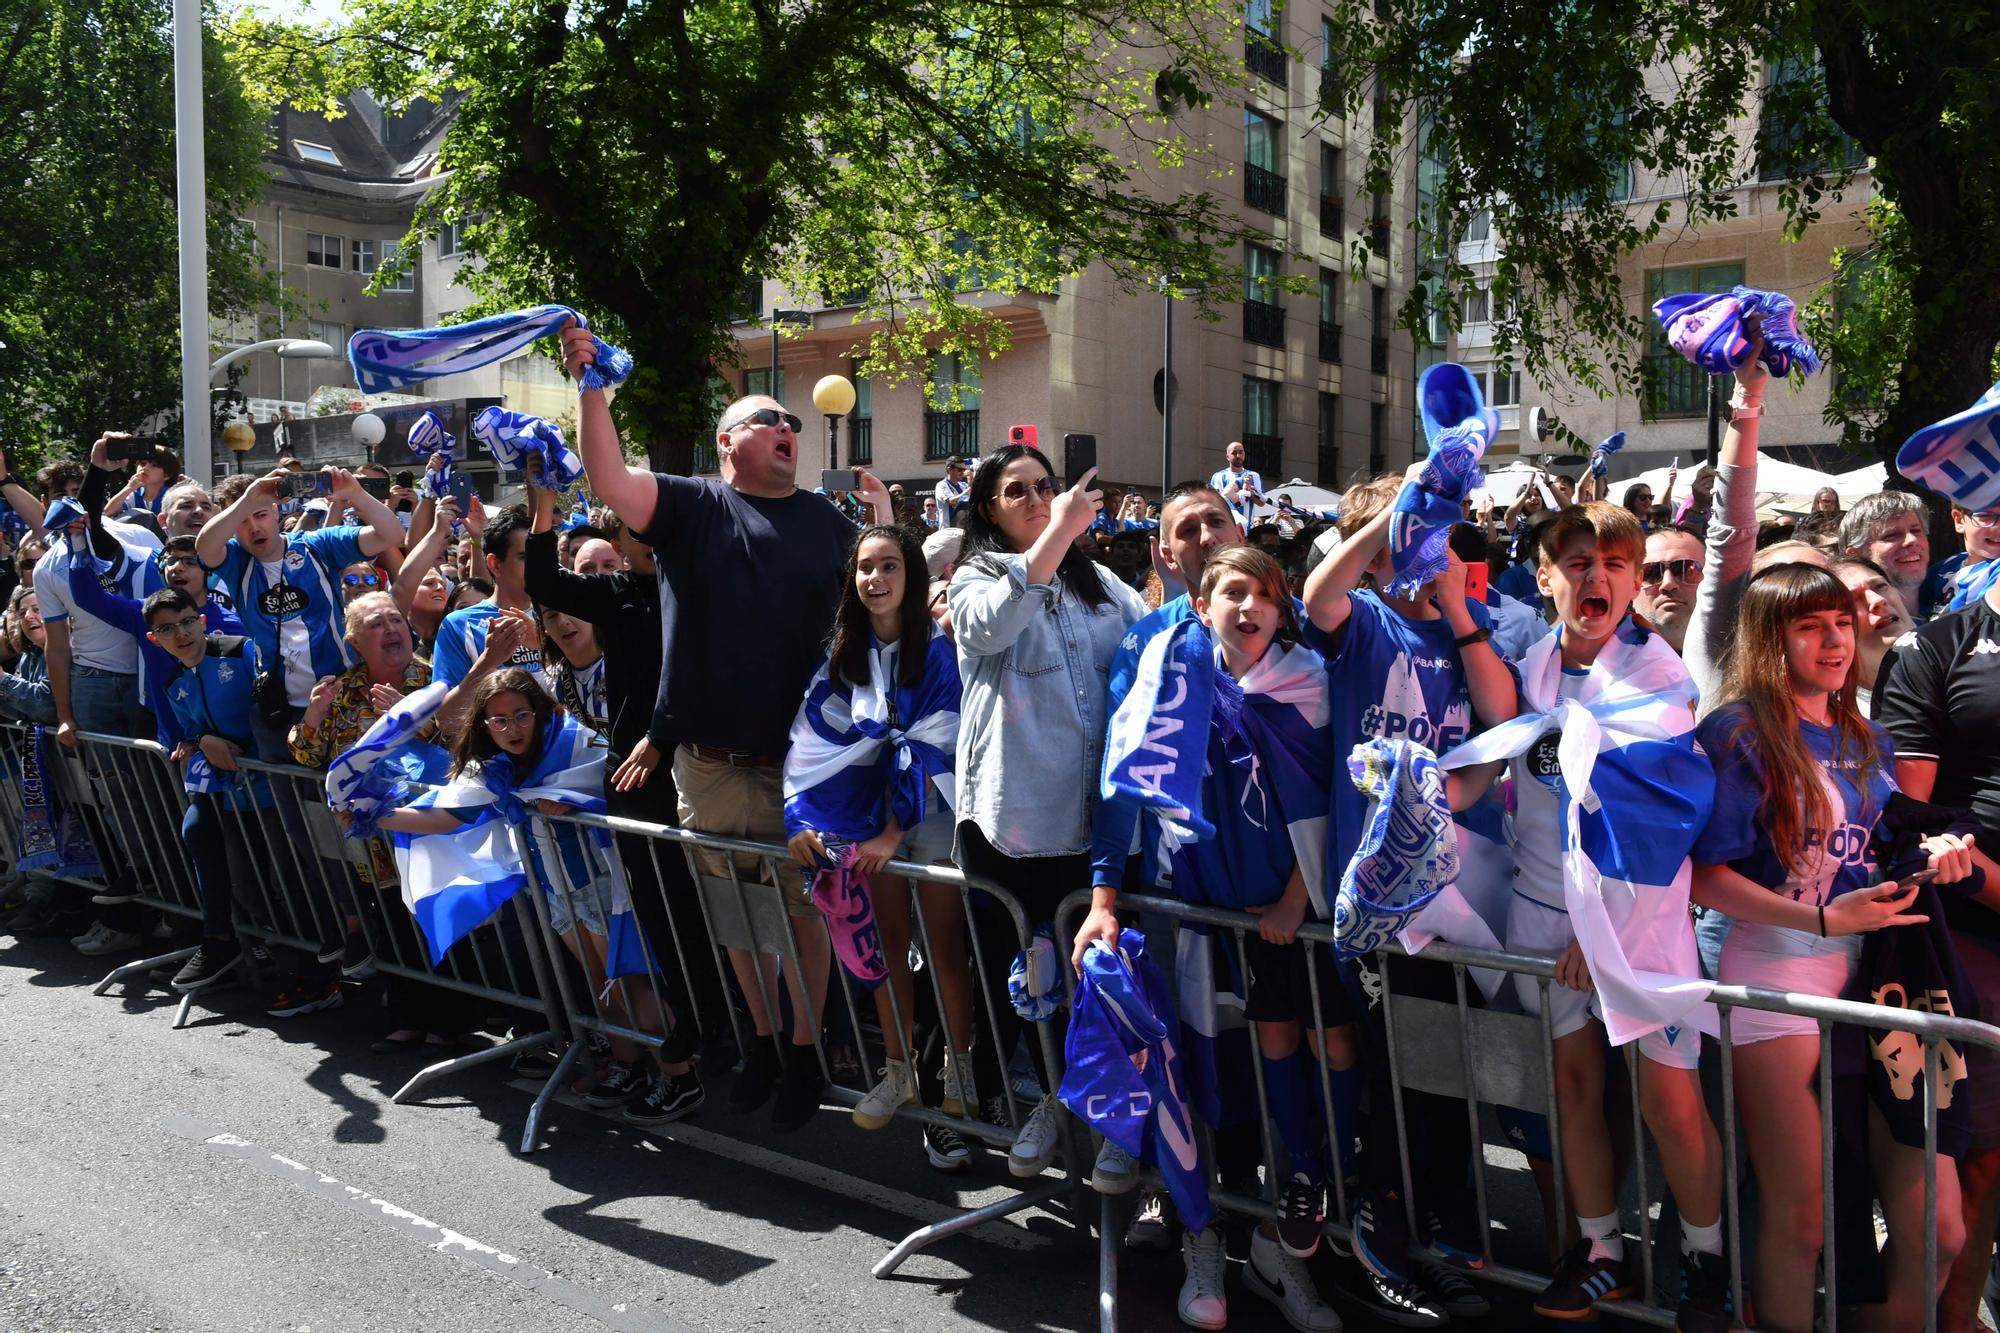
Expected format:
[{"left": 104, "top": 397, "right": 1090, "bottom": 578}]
[{"left": 1874, "top": 590, "right": 2000, "bottom": 1329}]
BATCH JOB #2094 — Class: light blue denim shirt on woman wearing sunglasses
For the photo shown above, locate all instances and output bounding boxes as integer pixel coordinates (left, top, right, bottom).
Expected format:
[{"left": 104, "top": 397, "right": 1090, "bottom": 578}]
[{"left": 948, "top": 554, "right": 1146, "bottom": 857}]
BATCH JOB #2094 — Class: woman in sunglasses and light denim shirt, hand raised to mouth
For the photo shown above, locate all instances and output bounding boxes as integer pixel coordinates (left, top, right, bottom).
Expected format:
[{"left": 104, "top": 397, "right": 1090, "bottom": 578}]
[{"left": 948, "top": 444, "right": 1146, "bottom": 1183}]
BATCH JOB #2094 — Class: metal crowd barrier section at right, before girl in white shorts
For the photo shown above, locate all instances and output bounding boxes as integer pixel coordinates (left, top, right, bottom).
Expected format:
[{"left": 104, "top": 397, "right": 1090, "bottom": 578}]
[{"left": 1056, "top": 891, "right": 2000, "bottom": 1333}]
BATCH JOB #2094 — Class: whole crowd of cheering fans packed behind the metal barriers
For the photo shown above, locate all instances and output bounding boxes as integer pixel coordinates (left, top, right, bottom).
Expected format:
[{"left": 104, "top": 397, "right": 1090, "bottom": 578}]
[{"left": 0, "top": 312, "right": 2000, "bottom": 1333}]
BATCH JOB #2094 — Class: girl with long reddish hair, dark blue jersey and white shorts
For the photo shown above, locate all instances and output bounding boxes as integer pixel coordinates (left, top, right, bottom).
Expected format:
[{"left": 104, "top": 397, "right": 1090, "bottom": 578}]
[{"left": 1692, "top": 564, "right": 1972, "bottom": 1333}]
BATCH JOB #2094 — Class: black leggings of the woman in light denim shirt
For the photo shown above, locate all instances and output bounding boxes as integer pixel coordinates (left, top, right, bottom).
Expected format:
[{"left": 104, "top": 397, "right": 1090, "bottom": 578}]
[{"left": 958, "top": 823, "right": 1090, "bottom": 1097}]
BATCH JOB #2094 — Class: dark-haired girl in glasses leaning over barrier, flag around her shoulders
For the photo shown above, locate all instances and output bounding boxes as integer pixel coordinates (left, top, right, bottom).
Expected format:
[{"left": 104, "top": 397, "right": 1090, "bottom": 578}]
[{"left": 376, "top": 667, "right": 702, "bottom": 1125}]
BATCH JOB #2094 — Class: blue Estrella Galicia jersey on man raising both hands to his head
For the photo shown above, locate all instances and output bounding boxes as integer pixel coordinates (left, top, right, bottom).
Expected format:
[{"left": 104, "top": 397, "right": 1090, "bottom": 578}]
[{"left": 216, "top": 526, "right": 368, "bottom": 707}]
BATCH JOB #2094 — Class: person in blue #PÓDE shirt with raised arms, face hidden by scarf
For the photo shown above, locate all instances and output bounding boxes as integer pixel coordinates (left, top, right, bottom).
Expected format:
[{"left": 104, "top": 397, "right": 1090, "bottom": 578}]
[{"left": 1304, "top": 462, "right": 1518, "bottom": 1323}]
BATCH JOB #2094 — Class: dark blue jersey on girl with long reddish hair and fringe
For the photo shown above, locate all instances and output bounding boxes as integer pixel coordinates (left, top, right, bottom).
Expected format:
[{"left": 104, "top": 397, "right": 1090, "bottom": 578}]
[{"left": 1694, "top": 703, "right": 1896, "bottom": 920}]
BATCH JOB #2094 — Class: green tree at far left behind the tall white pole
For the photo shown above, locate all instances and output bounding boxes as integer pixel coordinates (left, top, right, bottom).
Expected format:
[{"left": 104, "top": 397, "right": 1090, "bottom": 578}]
[{"left": 0, "top": 0, "right": 276, "bottom": 466}]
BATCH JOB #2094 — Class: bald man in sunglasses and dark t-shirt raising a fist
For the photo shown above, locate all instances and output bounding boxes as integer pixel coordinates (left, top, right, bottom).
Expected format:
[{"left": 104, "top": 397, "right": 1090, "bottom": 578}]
[{"left": 562, "top": 322, "right": 890, "bottom": 1129}]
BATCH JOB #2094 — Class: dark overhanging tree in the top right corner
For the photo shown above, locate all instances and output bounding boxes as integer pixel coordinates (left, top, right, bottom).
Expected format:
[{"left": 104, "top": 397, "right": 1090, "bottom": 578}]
[{"left": 1336, "top": 0, "right": 2000, "bottom": 466}]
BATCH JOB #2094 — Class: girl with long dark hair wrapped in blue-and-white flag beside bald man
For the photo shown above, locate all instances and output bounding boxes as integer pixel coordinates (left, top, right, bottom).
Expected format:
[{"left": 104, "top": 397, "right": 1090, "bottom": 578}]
[{"left": 784, "top": 524, "right": 978, "bottom": 1171}]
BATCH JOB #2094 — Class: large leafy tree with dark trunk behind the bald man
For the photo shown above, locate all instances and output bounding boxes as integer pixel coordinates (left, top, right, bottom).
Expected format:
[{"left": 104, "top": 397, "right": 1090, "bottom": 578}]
[{"left": 228, "top": 0, "right": 1242, "bottom": 470}]
